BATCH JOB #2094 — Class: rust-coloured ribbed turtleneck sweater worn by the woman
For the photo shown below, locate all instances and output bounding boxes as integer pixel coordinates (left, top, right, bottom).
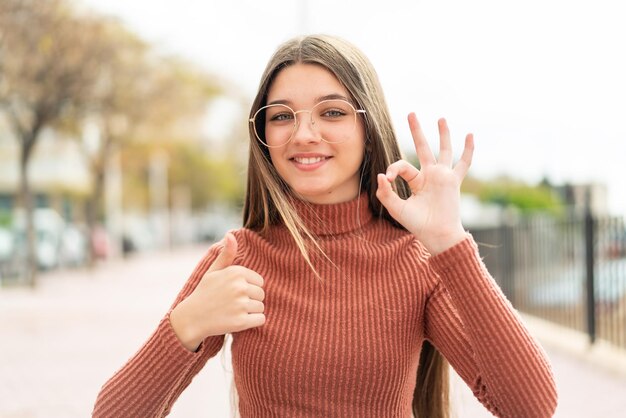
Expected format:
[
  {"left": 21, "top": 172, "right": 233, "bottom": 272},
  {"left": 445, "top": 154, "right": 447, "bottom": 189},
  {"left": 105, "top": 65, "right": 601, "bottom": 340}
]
[{"left": 94, "top": 196, "right": 556, "bottom": 418}]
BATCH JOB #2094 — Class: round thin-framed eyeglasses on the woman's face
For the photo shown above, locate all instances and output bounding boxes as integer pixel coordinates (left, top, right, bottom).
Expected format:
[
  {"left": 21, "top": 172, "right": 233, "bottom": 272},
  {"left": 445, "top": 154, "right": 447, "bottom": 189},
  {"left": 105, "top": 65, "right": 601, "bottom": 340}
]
[{"left": 249, "top": 99, "right": 365, "bottom": 148}]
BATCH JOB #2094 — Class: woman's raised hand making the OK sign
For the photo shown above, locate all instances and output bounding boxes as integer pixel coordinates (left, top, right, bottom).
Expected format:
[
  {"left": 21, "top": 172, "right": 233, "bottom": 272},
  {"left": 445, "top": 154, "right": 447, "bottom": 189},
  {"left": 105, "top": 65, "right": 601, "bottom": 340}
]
[{"left": 376, "top": 113, "right": 474, "bottom": 255}]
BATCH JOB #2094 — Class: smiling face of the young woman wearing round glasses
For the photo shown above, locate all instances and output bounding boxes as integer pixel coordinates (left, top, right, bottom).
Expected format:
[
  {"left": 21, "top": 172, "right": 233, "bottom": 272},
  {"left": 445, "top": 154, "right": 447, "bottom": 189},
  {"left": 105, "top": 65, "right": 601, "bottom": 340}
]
[{"left": 265, "top": 64, "right": 365, "bottom": 204}]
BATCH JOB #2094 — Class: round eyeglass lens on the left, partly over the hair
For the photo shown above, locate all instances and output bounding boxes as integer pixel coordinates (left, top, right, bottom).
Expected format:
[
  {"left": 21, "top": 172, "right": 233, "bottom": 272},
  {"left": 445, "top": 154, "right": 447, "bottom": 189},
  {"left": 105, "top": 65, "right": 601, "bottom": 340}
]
[{"left": 254, "top": 104, "right": 296, "bottom": 147}]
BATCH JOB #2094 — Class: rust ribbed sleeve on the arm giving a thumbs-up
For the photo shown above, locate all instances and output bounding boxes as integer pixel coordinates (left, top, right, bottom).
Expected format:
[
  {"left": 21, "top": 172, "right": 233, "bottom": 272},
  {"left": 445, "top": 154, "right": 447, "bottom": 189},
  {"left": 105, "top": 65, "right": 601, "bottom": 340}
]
[{"left": 93, "top": 246, "right": 224, "bottom": 418}]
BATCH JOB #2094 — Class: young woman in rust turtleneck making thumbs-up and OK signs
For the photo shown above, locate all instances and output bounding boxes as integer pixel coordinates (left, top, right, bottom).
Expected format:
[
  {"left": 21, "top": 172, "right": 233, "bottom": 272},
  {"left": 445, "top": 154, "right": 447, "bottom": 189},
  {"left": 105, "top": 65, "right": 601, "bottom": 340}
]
[{"left": 94, "top": 36, "right": 556, "bottom": 418}]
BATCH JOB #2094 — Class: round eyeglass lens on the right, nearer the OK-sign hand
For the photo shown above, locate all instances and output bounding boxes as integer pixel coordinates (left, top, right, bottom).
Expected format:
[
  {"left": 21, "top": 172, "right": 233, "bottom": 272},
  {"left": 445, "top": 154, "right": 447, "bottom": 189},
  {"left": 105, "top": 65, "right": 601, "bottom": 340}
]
[{"left": 311, "top": 100, "right": 356, "bottom": 144}]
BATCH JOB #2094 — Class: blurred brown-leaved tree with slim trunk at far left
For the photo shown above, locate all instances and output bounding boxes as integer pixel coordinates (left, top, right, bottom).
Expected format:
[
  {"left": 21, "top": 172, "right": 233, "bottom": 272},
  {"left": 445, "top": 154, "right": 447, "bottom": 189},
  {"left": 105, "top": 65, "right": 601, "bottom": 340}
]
[{"left": 0, "top": 0, "right": 112, "bottom": 286}]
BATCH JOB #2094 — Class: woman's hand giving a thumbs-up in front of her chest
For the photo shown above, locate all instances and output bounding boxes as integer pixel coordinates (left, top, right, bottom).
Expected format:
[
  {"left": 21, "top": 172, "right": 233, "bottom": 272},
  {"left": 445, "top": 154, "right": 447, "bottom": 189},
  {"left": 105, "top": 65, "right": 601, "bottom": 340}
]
[{"left": 170, "top": 233, "right": 265, "bottom": 351}]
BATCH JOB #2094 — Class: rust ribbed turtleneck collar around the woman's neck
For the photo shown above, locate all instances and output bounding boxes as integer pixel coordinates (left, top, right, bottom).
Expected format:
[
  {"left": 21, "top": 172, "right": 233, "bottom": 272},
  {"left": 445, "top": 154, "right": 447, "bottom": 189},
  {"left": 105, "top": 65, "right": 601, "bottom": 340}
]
[{"left": 286, "top": 193, "right": 373, "bottom": 236}]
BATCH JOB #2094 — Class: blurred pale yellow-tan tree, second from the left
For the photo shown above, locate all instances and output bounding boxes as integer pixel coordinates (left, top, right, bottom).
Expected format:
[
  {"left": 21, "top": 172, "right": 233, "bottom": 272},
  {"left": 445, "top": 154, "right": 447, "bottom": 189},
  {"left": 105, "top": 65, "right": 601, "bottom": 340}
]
[{"left": 79, "top": 22, "right": 220, "bottom": 255}]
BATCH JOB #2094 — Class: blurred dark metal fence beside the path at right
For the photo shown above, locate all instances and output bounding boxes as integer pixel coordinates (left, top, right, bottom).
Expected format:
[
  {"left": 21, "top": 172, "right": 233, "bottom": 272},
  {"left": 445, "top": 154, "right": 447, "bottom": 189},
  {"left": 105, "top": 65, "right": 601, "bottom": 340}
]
[{"left": 470, "top": 209, "right": 626, "bottom": 349}]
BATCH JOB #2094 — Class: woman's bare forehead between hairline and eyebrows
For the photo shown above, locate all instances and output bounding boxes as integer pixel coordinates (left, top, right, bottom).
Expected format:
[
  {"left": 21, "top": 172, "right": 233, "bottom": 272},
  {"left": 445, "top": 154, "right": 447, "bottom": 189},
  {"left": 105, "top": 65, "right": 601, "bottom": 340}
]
[{"left": 267, "top": 63, "right": 350, "bottom": 106}]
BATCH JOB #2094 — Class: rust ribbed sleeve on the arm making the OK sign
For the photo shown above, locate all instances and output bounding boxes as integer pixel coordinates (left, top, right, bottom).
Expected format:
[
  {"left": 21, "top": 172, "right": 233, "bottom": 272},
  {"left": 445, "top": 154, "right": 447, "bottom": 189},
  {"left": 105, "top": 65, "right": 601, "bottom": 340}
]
[{"left": 425, "top": 237, "right": 557, "bottom": 418}]
